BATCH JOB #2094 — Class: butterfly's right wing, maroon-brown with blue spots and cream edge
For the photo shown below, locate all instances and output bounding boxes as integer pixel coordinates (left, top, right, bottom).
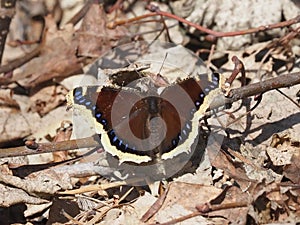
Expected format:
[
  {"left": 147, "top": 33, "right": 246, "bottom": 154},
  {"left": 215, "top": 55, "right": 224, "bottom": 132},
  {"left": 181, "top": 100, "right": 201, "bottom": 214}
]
[{"left": 161, "top": 74, "right": 218, "bottom": 159}]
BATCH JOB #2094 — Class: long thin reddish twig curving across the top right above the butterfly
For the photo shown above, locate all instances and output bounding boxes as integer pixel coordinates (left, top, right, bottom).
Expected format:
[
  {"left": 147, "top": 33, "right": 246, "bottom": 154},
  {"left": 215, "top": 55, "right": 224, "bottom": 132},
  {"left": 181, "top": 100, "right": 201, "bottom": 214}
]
[{"left": 108, "top": 5, "right": 300, "bottom": 37}]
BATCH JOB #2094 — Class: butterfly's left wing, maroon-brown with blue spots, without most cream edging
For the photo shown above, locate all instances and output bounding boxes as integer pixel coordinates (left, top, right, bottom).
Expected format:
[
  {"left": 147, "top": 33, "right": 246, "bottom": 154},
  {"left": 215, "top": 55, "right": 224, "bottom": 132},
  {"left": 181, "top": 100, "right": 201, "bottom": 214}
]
[{"left": 73, "top": 86, "right": 151, "bottom": 161}]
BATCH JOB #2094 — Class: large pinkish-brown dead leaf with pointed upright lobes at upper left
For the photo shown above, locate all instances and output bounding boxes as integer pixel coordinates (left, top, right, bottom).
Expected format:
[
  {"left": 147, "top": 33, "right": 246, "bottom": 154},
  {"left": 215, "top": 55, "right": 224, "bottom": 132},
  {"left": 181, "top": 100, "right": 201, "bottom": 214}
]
[{"left": 12, "top": 15, "right": 81, "bottom": 88}]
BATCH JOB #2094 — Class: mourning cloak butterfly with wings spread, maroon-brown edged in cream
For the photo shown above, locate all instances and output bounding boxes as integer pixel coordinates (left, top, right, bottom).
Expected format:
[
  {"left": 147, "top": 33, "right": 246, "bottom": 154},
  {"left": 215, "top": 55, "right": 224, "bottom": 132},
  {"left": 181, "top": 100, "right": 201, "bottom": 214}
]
[{"left": 67, "top": 71, "right": 219, "bottom": 164}]
